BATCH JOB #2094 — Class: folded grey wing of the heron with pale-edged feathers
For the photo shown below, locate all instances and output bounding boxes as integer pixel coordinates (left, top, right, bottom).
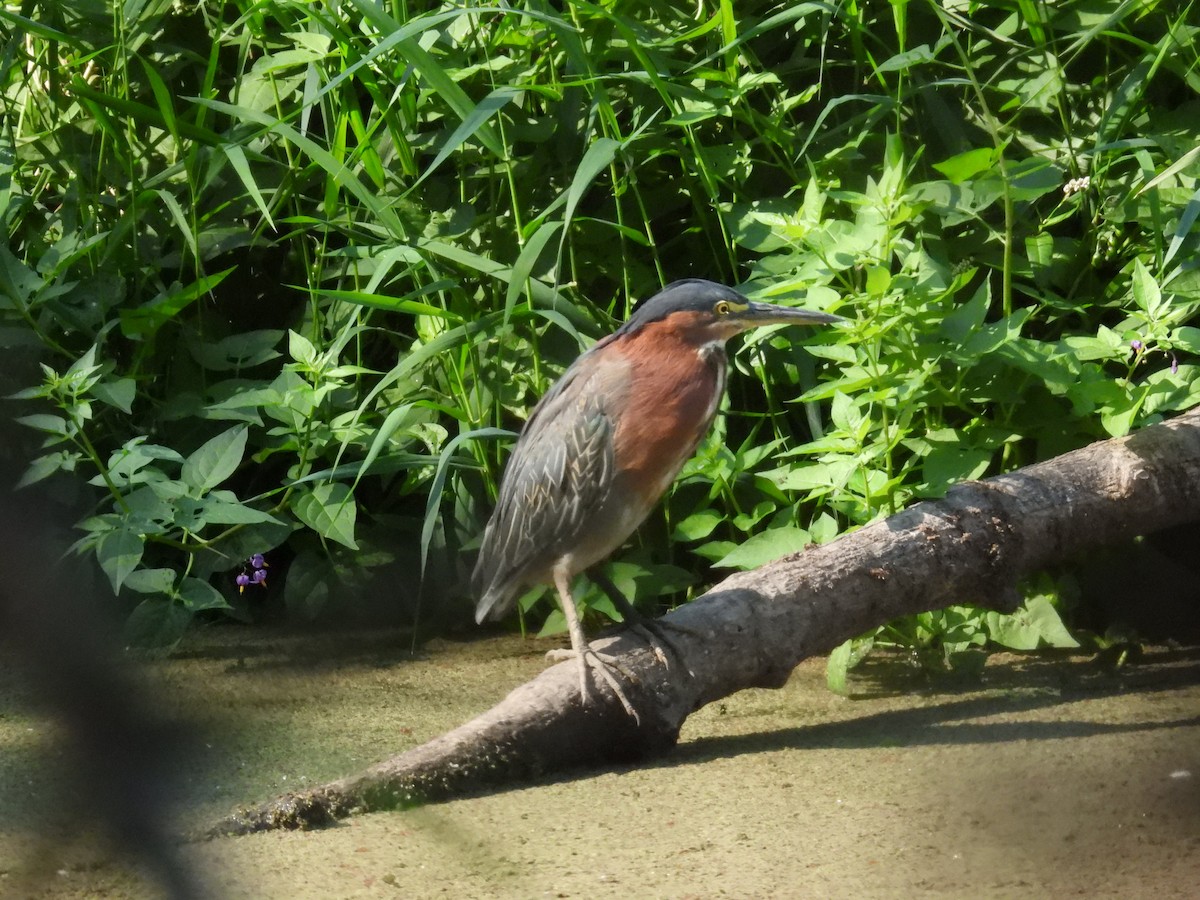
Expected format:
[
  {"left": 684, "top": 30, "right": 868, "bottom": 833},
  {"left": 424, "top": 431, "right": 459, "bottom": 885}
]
[{"left": 472, "top": 358, "right": 613, "bottom": 622}]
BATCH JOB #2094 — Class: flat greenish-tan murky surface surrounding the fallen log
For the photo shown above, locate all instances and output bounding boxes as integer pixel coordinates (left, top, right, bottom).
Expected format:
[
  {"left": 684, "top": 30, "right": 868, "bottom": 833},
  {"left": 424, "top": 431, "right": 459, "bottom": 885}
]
[{"left": 0, "top": 628, "right": 1200, "bottom": 900}]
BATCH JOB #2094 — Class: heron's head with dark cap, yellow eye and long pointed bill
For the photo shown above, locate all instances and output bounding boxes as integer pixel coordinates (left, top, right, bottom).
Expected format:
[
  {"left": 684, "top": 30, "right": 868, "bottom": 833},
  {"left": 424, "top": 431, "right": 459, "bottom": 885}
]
[{"left": 617, "top": 278, "right": 846, "bottom": 346}]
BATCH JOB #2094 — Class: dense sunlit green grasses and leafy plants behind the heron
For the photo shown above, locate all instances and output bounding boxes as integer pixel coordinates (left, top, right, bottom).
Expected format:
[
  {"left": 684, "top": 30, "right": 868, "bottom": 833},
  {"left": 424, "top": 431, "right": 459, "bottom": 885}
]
[{"left": 0, "top": 0, "right": 1200, "bottom": 682}]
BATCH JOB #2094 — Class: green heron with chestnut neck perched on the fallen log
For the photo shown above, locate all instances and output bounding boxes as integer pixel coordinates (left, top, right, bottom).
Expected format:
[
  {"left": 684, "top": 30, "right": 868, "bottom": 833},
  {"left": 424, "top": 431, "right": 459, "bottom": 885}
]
[{"left": 472, "top": 278, "right": 844, "bottom": 719}]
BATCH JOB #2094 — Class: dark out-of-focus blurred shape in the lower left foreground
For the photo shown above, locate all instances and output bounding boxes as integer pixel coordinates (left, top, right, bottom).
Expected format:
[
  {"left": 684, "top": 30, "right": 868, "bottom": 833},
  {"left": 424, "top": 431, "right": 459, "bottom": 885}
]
[{"left": 0, "top": 460, "right": 203, "bottom": 900}]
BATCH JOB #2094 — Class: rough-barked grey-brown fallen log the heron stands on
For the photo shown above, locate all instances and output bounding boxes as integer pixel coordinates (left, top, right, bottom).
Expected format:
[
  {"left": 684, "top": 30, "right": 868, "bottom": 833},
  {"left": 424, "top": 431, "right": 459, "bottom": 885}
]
[{"left": 212, "top": 409, "right": 1200, "bottom": 834}]
